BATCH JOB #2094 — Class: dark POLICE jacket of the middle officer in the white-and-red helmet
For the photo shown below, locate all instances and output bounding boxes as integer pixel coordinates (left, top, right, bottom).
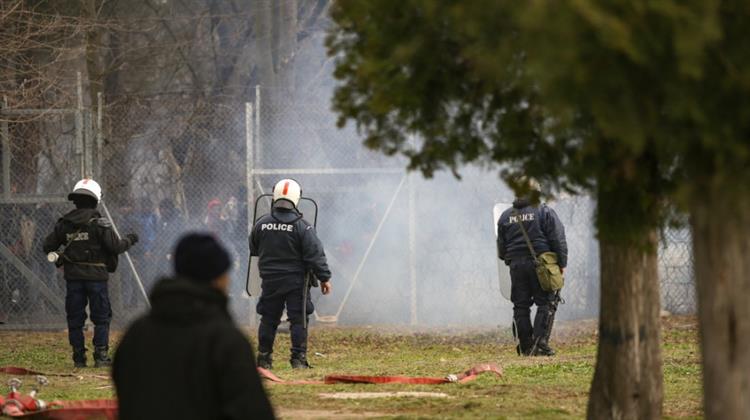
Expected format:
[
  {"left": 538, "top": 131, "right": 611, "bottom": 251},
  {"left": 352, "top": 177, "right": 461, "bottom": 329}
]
[{"left": 250, "top": 208, "right": 331, "bottom": 282}]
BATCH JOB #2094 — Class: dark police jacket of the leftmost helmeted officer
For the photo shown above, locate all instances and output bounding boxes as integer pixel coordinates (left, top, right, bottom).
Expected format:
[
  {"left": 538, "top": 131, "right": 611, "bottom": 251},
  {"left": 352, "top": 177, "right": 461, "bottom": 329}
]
[{"left": 42, "top": 209, "right": 132, "bottom": 280}]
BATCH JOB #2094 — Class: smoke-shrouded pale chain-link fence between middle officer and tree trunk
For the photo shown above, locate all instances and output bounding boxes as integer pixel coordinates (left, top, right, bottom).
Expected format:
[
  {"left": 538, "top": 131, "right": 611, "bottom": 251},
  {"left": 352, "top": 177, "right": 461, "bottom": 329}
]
[{"left": 251, "top": 90, "right": 599, "bottom": 326}]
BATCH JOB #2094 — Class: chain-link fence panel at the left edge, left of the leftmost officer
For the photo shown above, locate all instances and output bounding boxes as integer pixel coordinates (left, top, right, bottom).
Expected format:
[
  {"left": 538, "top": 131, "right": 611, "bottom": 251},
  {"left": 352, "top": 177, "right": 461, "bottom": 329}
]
[{"left": 0, "top": 101, "right": 93, "bottom": 327}]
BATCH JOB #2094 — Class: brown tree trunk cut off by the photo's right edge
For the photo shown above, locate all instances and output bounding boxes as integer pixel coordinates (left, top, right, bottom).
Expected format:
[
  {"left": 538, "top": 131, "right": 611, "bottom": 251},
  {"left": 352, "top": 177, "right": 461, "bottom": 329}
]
[{"left": 690, "top": 186, "right": 750, "bottom": 419}]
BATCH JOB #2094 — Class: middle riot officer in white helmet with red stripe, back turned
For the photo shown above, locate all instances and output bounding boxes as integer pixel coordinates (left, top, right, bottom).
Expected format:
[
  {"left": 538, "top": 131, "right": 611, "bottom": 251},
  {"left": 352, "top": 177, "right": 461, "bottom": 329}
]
[{"left": 250, "top": 179, "right": 331, "bottom": 369}]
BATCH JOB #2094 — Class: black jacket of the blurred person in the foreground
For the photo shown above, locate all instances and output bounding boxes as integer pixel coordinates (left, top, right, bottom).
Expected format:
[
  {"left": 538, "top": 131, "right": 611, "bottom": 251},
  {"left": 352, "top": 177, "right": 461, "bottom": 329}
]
[{"left": 112, "top": 279, "right": 274, "bottom": 420}]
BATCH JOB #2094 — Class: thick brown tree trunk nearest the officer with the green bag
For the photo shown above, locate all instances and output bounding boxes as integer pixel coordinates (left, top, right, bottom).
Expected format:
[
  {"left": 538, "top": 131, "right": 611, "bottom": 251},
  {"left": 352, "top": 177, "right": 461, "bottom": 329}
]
[{"left": 588, "top": 233, "right": 663, "bottom": 420}]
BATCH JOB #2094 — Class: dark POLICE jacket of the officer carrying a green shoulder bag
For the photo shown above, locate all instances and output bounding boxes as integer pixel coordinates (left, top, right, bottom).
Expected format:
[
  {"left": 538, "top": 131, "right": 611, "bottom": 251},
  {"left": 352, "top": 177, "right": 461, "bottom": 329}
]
[{"left": 497, "top": 199, "right": 568, "bottom": 268}]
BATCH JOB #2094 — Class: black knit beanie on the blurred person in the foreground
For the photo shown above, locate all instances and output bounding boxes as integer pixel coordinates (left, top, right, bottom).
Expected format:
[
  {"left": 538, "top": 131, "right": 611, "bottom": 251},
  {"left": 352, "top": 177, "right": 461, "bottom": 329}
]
[{"left": 174, "top": 232, "right": 232, "bottom": 283}]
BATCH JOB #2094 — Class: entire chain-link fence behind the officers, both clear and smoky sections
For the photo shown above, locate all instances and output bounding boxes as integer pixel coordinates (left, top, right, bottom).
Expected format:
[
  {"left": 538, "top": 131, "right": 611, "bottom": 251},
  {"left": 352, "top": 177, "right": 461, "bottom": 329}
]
[{"left": 0, "top": 84, "right": 695, "bottom": 328}]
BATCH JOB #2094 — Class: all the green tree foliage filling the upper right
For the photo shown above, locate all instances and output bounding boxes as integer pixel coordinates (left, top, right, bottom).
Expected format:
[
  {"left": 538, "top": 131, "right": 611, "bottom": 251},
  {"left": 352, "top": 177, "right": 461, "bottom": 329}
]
[{"left": 328, "top": 0, "right": 750, "bottom": 245}]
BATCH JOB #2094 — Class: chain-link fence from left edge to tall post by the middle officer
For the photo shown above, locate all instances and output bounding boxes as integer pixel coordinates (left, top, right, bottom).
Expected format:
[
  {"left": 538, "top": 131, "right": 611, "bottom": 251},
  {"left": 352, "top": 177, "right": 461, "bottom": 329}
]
[{"left": 0, "top": 96, "right": 254, "bottom": 327}]
